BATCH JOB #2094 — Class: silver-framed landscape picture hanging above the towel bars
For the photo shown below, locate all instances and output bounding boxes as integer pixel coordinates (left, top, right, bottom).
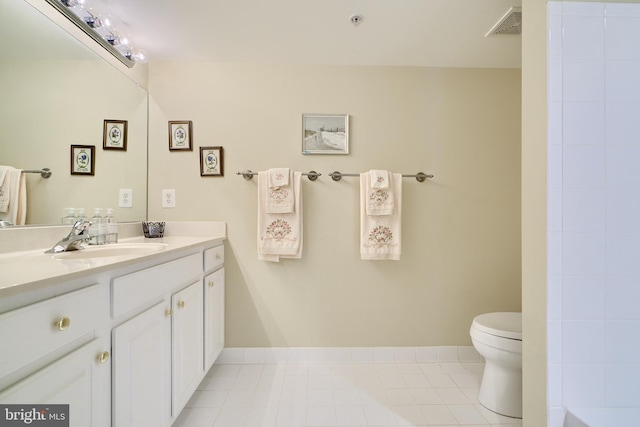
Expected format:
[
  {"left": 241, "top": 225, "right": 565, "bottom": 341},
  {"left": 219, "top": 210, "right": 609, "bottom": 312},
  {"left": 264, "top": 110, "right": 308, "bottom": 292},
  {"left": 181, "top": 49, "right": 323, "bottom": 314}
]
[{"left": 302, "top": 114, "right": 349, "bottom": 154}]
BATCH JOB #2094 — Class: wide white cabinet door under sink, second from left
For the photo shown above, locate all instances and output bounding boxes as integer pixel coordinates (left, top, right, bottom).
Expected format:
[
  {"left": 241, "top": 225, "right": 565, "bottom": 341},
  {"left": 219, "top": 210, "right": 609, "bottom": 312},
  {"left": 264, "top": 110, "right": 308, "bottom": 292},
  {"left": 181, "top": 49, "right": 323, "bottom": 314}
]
[{"left": 112, "top": 302, "right": 171, "bottom": 427}]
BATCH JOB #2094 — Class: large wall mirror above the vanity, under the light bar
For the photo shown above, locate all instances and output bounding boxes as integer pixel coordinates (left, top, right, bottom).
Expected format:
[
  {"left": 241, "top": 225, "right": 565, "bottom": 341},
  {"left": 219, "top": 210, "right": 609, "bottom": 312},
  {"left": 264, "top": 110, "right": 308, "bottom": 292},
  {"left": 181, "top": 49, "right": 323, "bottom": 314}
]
[{"left": 0, "top": 0, "right": 148, "bottom": 225}]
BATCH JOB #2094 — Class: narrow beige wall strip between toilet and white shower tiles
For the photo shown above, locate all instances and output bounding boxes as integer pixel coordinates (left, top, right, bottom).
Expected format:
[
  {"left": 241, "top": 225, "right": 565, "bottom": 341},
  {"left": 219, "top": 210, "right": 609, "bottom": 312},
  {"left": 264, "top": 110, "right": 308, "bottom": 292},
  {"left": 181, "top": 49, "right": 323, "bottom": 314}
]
[{"left": 522, "top": 0, "right": 547, "bottom": 427}]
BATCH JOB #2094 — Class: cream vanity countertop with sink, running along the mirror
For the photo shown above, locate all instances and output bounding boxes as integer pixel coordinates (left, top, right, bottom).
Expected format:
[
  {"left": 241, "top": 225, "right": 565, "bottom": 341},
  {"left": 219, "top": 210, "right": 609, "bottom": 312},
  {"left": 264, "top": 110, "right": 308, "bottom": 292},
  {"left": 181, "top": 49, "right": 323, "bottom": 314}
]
[{"left": 0, "top": 224, "right": 226, "bottom": 298}]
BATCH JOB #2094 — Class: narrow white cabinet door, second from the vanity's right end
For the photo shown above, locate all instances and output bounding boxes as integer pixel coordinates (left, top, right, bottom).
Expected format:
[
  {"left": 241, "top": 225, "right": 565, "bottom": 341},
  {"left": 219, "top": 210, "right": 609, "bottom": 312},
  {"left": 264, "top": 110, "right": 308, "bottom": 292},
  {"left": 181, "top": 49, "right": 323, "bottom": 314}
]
[{"left": 171, "top": 282, "right": 204, "bottom": 417}]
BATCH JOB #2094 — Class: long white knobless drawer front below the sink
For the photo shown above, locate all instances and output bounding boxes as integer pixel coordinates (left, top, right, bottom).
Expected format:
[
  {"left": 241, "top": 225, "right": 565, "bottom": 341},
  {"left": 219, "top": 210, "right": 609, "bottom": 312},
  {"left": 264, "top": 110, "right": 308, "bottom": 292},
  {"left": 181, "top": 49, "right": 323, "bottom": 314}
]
[{"left": 111, "top": 253, "right": 202, "bottom": 318}]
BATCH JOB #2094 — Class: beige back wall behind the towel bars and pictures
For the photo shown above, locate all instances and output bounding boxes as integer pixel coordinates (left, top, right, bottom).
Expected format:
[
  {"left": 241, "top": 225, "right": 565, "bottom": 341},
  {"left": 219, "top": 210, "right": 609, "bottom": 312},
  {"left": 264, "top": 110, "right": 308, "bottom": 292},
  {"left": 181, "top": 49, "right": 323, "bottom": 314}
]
[{"left": 149, "top": 62, "right": 521, "bottom": 347}]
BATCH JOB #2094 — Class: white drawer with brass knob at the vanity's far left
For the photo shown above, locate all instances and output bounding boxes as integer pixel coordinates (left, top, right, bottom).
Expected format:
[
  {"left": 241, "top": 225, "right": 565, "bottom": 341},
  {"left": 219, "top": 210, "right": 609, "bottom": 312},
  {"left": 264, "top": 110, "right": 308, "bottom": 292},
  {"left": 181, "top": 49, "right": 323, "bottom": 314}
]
[{"left": 0, "top": 285, "right": 109, "bottom": 378}]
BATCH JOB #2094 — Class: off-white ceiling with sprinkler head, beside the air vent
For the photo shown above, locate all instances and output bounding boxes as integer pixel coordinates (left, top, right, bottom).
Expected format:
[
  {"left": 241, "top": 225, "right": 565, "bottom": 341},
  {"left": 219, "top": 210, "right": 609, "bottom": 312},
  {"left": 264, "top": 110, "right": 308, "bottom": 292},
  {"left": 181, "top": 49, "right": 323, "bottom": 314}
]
[{"left": 93, "top": 0, "right": 521, "bottom": 68}]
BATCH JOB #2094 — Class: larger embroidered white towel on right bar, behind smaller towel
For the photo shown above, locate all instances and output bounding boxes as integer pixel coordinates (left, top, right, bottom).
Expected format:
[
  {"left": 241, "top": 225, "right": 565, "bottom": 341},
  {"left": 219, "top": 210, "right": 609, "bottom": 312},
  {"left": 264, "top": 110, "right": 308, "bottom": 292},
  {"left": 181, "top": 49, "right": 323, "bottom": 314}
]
[{"left": 360, "top": 173, "right": 402, "bottom": 261}]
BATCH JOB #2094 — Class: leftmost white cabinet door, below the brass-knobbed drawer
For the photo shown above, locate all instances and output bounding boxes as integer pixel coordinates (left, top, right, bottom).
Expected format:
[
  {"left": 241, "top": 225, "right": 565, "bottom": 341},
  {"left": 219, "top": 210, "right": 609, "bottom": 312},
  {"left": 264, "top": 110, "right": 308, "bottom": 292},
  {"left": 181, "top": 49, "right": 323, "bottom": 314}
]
[{"left": 0, "top": 338, "right": 111, "bottom": 427}]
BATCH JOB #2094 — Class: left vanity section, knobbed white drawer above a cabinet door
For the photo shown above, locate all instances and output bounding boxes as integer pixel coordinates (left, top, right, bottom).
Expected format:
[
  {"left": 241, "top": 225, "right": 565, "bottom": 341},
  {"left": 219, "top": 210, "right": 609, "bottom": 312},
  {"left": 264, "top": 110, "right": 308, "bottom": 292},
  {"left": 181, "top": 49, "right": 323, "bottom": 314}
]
[{"left": 0, "top": 284, "right": 111, "bottom": 427}]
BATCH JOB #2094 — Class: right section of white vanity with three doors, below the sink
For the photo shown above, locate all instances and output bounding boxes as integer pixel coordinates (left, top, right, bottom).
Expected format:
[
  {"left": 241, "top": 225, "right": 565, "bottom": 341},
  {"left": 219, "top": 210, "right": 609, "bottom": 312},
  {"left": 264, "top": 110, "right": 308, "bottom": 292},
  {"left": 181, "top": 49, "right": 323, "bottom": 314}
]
[{"left": 111, "top": 245, "right": 224, "bottom": 427}]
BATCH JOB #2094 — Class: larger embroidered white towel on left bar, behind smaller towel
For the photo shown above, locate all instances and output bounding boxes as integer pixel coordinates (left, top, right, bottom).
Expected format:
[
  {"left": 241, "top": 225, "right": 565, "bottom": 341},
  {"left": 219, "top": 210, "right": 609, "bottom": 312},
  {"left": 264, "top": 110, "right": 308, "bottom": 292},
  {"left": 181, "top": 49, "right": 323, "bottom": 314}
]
[{"left": 258, "top": 172, "right": 302, "bottom": 262}]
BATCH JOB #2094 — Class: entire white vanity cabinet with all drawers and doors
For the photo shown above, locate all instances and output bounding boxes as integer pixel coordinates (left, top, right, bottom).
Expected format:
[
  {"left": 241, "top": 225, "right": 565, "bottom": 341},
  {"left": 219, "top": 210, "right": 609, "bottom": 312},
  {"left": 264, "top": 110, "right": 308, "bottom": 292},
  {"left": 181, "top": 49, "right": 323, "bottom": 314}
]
[{"left": 0, "top": 237, "right": 224, "bottom": 427}]
